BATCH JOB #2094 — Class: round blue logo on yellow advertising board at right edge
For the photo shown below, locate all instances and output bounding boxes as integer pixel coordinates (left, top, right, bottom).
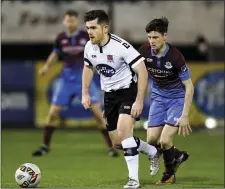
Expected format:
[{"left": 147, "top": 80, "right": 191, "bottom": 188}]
[{"left": 194, "top": 70, "right": 225, "bottom": 119}]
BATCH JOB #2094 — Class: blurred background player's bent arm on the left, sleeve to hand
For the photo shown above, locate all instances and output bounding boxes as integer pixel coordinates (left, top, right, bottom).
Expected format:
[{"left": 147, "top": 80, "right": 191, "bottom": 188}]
[{"left": 39, "top": 37, "right": 60, "bottom": 75}]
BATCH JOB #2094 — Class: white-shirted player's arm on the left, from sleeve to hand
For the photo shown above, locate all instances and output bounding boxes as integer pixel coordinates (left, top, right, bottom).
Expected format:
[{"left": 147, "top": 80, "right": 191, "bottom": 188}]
[{"left": 82, "top": 45, "right": 94, "bottom": 109}]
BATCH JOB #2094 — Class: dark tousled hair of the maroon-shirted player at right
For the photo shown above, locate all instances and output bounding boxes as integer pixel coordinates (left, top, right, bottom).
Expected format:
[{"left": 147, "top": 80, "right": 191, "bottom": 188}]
[{"left": 145, "top": 17, "right": 169, "bottom": 34}]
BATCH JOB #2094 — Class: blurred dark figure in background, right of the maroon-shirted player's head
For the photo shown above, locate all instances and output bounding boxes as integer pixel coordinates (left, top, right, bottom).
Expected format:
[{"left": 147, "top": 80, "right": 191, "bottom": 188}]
[{"left": 195, "top": 34, "right": 209, "bottom": 62}]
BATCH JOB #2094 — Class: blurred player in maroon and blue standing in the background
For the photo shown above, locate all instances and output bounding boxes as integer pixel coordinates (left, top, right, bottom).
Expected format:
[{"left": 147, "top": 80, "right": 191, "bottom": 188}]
[{"left": 32, "top": 10, "right": 118, "bottom": 157}]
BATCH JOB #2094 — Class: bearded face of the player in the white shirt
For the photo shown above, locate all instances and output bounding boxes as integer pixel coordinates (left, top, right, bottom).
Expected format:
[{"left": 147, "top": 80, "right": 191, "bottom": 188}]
[{"left": 86, "top": 19, "right": 108, "bottom": 44}]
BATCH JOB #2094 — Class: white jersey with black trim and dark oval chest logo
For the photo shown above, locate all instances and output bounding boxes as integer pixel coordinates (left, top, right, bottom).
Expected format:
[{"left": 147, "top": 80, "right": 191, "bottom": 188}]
[{"left": 84, "top": 34, "right": 144, "bottom": 92}]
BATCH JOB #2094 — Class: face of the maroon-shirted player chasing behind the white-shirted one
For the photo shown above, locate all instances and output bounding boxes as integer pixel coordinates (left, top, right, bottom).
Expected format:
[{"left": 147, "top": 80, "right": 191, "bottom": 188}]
[{"left": 148, "top": 31, "right": 167, "bottom": 50}]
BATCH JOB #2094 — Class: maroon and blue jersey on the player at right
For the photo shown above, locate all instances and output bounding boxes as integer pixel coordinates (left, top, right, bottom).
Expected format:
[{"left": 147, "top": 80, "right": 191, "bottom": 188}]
[{"left": 139, "top": 43, "right": 190, "bottom": 98}]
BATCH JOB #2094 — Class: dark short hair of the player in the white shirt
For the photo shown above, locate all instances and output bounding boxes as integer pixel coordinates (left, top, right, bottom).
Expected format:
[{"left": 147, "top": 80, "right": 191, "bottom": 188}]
[{"left": 84, "top": 10, "right": 109, "bottom": 24}]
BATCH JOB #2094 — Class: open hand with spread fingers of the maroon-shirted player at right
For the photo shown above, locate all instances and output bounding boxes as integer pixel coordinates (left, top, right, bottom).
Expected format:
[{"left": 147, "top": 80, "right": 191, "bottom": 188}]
[{"left": 175, "top": 116, "right": 192, "bottom": 137}]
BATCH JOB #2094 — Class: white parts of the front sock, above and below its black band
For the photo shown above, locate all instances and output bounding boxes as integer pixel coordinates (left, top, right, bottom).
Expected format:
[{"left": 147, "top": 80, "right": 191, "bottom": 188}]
[{"left": 122, "top": 137, "right": 139, "bottom": 182}]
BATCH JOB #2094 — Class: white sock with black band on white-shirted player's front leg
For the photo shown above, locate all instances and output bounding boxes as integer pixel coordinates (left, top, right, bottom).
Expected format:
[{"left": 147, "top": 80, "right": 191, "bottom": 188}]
[{"left": 122, "top": 137, "right": 139, "bottom": 182}]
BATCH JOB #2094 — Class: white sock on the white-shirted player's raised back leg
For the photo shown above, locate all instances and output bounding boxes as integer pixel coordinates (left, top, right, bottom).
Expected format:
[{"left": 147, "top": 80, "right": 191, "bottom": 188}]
[{"left": 134, "top": 137, "right": 157, "bottom": 157}]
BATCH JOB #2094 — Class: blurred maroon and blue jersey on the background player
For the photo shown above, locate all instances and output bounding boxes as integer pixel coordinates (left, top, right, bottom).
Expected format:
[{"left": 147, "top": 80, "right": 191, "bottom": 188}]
[{"left": 53, "top": 29, "right": 89, "bottom": 82}]
